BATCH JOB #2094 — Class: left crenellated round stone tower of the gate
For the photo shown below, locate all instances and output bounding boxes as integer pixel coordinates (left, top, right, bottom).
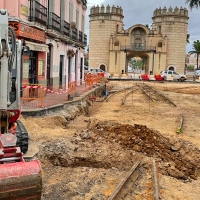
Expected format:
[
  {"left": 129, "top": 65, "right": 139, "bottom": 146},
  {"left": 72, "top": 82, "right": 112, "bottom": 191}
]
[{"left": 89, "top": 5, "right": 124, "bottom": 70}]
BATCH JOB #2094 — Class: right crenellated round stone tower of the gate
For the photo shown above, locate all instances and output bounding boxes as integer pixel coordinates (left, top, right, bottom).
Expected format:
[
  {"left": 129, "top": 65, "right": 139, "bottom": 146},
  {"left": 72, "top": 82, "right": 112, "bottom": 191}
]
[{"left": 152, "top": 7, "right": 189, "bottom": 73}]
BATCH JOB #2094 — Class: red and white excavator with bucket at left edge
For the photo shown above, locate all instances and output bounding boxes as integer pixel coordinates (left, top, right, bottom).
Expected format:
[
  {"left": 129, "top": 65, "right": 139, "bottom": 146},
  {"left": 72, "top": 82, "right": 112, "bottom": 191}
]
[{"left": 0, "top": 9, "right": 42, "bottom": 200}]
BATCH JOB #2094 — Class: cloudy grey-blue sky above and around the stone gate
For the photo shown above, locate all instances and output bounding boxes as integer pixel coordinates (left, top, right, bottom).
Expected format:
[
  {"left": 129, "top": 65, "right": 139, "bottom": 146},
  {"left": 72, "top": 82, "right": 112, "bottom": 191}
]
[{"left": 86, "top": 0, "right": 200, "bottom": 53}]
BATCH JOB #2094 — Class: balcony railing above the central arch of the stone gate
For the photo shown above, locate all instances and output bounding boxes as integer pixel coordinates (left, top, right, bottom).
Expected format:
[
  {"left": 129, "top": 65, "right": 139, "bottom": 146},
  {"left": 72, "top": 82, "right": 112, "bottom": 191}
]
[{"left": 120, "top": 43, "right": 156, "bottom": 52}]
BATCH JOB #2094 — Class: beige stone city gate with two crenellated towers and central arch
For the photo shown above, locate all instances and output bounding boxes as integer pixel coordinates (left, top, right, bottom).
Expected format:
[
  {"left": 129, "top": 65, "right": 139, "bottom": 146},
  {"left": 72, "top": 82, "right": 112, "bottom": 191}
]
[{"left": 89, "top": 5, "right": 188, "bottom": 74}]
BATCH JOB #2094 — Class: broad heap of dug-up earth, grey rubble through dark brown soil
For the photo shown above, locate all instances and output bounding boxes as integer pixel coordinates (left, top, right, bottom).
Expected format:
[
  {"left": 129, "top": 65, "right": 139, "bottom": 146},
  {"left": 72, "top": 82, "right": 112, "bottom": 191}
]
[{"left": 38, "top": 122, "right": 200, "bottom": 180}]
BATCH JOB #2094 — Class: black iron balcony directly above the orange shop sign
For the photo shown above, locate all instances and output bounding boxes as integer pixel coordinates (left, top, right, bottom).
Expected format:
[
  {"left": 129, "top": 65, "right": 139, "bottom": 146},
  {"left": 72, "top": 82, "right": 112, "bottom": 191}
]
[{"left": 29, "top": 0, "right": 47, "bottom": 26}]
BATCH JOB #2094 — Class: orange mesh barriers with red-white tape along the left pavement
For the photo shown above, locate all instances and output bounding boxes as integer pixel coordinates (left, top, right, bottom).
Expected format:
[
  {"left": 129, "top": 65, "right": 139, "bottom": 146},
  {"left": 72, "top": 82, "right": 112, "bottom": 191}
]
[{"left": 21, "top": 74, "right": 104, "bottom": 109}]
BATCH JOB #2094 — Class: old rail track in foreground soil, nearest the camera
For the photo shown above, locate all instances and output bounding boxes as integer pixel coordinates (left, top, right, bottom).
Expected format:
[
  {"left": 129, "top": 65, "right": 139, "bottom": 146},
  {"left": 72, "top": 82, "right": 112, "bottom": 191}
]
[{"left": 108, "top": 159, "right": 159, "bottom": 200}]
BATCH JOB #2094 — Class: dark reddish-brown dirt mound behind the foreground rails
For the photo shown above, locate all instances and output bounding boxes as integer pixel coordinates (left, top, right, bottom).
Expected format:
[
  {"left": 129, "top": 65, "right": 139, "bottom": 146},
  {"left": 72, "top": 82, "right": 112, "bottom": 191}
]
[{"left": 89, "top": 122, "right": 200, "bottom": 180}]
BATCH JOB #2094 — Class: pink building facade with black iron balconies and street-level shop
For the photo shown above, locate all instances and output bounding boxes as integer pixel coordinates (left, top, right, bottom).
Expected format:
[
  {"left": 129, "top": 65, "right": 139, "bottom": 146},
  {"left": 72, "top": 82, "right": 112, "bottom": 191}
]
[{"left": 0, "top": 0, "right": 87, "bottom": 90}]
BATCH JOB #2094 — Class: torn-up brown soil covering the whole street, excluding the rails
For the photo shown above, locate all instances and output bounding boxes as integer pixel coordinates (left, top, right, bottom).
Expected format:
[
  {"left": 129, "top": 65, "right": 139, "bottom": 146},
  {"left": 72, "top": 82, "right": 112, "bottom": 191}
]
[{"left": 21, "top": 82, "right": 200, "bottom": 200}]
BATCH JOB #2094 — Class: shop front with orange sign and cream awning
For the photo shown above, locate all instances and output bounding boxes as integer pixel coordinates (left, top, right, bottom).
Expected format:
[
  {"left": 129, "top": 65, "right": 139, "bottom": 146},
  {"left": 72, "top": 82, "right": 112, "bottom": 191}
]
[{"left": 9, "top": 21, "right": 49, "bottom": 86}]
